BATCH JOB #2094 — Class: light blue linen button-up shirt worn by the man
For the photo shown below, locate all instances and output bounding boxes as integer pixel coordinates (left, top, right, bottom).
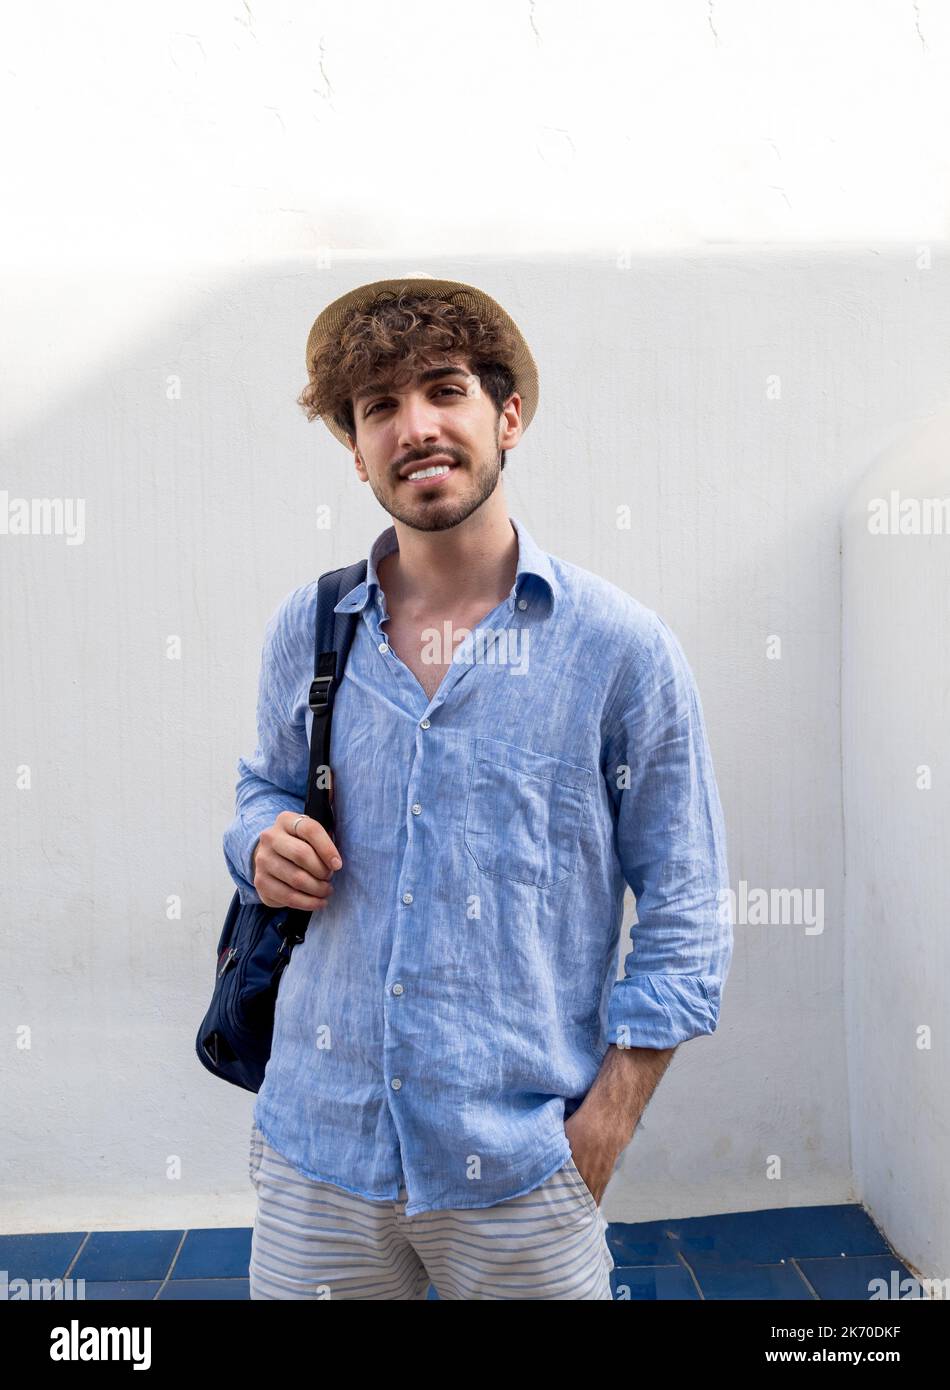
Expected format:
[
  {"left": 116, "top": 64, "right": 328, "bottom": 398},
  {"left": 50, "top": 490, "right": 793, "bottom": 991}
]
[{"left": 224, "top": 517, "right": 733, "bottom": 1216}]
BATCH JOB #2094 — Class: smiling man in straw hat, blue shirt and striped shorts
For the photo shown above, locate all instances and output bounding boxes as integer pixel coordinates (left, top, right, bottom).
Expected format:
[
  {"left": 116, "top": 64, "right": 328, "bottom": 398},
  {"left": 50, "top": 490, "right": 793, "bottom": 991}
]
[{"left": 224, "top": 277, "right": 732, "bottom": 1298}]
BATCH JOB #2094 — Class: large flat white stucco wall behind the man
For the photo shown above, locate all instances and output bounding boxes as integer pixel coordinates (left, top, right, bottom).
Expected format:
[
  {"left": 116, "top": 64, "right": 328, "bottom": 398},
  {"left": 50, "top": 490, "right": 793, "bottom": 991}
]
[{"left": 0, "top": 3, "right": 950, "bottom": 1273}]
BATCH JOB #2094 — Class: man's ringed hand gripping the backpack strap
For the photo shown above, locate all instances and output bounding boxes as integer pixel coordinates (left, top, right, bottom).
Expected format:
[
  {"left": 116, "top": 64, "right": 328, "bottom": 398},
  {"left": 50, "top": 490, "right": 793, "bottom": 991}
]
[{"left": 250, "top": 810, "right": 342, "bottom": 912}]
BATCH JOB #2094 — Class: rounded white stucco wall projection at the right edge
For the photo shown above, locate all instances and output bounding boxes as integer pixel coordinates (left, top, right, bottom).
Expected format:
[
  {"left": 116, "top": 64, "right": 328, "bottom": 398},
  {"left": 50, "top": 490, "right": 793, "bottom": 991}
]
[{"left": 842, "top": 409, "right": 950, "bottom": 1277}]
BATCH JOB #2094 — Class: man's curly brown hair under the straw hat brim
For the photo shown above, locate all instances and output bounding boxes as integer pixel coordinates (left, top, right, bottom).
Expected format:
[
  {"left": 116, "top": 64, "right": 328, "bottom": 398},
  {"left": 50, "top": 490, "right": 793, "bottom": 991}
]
[{"left": 298, "top": 289, "right": 516, "bottom": 468}]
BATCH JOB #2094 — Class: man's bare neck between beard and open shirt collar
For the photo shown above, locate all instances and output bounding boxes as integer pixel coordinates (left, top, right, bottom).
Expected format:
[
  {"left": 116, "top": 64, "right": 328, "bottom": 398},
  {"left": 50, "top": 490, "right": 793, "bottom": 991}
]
[{"left": 378, "top": 506, "right": 517, "bottom": 613}]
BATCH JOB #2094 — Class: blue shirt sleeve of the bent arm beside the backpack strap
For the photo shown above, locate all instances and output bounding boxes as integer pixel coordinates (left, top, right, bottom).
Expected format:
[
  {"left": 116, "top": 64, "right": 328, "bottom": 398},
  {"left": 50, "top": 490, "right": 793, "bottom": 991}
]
[{"left": 224, "top": 585, "right": 313, "bottom": 902}]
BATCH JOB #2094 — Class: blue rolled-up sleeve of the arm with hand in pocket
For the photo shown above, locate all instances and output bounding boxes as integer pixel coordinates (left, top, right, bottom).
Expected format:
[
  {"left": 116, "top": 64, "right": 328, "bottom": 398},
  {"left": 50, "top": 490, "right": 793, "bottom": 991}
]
[{"left": 604, "top": 613, "right": 733, "bottom": 1048}]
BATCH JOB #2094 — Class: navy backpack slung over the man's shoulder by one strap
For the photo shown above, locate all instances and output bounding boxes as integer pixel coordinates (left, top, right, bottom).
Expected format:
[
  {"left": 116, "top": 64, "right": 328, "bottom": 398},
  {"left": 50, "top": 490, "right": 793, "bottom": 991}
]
[{"left": 195, "top": 560, "right": 366, "bottom": 1091}]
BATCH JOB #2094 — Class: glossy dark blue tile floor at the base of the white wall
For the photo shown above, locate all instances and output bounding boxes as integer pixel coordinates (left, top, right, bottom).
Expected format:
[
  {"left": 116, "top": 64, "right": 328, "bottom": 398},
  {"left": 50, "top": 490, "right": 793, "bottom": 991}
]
[{"left": 0, "top": 1204, "right": 912, "bottom": 1302}]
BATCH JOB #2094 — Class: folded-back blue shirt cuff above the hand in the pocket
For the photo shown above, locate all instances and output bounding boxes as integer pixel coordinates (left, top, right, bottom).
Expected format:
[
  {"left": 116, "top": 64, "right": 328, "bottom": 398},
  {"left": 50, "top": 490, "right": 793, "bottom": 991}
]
[{"left": 606, "top": 974, "right": 719, "bottom": 1048}]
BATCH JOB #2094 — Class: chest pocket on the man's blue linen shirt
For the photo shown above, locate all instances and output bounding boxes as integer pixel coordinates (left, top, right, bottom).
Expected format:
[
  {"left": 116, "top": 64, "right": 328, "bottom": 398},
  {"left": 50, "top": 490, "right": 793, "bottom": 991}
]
[{"left": 463, "top": 738, "right": 593, "bottom": 888}]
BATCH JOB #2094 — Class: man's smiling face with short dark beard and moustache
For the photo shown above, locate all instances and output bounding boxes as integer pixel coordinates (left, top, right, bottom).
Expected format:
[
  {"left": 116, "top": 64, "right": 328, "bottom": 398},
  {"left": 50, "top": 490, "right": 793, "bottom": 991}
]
[{"left": 351, "top": 357, "right": 522, "bottom": 531}]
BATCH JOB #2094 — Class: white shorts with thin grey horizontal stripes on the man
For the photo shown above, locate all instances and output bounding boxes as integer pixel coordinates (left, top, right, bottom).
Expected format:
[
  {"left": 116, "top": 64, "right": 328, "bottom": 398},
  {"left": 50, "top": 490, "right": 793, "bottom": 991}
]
[{"left": 249, "top": 1125, "right": 615, "bottom": 1300}]
